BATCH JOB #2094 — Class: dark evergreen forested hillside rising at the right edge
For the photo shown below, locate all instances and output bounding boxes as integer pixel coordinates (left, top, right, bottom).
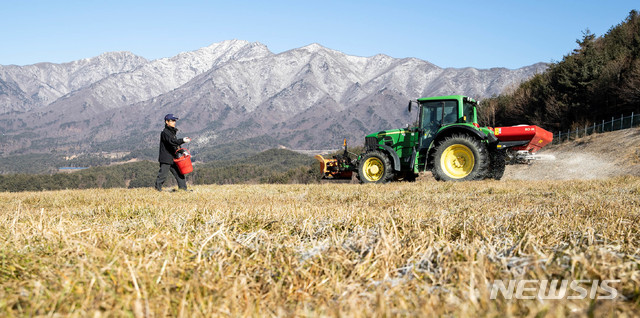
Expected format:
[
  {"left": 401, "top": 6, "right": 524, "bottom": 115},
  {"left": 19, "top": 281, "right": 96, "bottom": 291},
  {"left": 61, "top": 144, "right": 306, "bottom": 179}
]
[{"left": 479, "top": 10, "right": 640, "bottom": 131}]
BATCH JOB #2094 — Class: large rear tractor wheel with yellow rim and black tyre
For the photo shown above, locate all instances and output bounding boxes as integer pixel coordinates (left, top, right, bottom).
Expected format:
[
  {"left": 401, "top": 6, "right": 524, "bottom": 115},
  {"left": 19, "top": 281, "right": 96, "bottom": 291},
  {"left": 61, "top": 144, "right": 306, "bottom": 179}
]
[{"left": 432, "top": 134, "right": 489, "bottom": 181}]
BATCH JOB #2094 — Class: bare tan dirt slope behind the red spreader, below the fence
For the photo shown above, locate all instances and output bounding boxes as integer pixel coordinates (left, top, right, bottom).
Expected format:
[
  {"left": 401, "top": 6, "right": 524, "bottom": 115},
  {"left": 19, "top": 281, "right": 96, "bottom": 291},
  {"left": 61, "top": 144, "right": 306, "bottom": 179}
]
[{"left": 504, "top": 128, "right": 640, "bottom": 180}]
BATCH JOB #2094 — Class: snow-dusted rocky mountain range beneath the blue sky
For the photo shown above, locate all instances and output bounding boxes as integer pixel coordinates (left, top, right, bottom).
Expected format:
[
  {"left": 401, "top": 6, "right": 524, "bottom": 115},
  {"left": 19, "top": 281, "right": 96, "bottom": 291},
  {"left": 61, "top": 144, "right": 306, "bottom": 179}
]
[{"left": 0, "top": 40, "right": 547, "bottom": 155}]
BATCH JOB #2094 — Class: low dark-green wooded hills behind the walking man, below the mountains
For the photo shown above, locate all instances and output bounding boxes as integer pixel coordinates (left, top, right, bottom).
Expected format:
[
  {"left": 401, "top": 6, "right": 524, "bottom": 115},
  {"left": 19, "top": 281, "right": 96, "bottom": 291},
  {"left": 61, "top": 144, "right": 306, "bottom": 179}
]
[{"left": 0, "top": 149, "right": 320, "bottom": 192}]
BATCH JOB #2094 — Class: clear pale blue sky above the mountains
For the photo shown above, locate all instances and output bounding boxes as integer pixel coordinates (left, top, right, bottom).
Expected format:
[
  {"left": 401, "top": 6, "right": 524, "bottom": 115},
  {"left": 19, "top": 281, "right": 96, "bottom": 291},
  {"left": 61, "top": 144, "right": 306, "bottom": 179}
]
[{"left": 0, "top": 0, "right": 640, "bottom": 68}]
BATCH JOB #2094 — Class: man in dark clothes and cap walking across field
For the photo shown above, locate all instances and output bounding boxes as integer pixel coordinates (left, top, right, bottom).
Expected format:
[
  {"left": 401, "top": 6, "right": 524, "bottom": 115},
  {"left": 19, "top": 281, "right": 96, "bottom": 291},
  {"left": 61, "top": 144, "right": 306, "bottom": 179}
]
[{"left": 156, "top": 114, "right": 191, "bottom": 191}]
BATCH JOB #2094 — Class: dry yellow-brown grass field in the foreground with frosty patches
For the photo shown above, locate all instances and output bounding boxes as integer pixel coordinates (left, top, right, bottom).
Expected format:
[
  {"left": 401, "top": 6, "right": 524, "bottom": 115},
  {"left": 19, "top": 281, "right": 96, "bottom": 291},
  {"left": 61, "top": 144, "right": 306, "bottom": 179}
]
[{"left": 0, "top": 177, "right": 640, "bottom": 317}]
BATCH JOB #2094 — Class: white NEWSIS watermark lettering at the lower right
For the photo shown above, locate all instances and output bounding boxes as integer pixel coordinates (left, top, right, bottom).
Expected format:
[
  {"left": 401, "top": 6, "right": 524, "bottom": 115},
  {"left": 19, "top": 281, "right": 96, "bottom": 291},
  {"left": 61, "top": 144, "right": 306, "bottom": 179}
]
[{"left": 489, "top": 279, "right": 620, "bottom": 300}]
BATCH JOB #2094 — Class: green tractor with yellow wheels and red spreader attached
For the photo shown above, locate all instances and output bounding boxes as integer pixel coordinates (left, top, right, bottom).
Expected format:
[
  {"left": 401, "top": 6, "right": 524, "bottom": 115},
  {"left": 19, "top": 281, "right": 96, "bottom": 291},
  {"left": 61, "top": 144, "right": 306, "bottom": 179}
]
[{"left": 316, "top": 95, "right": 553, "bottom": 183}]
